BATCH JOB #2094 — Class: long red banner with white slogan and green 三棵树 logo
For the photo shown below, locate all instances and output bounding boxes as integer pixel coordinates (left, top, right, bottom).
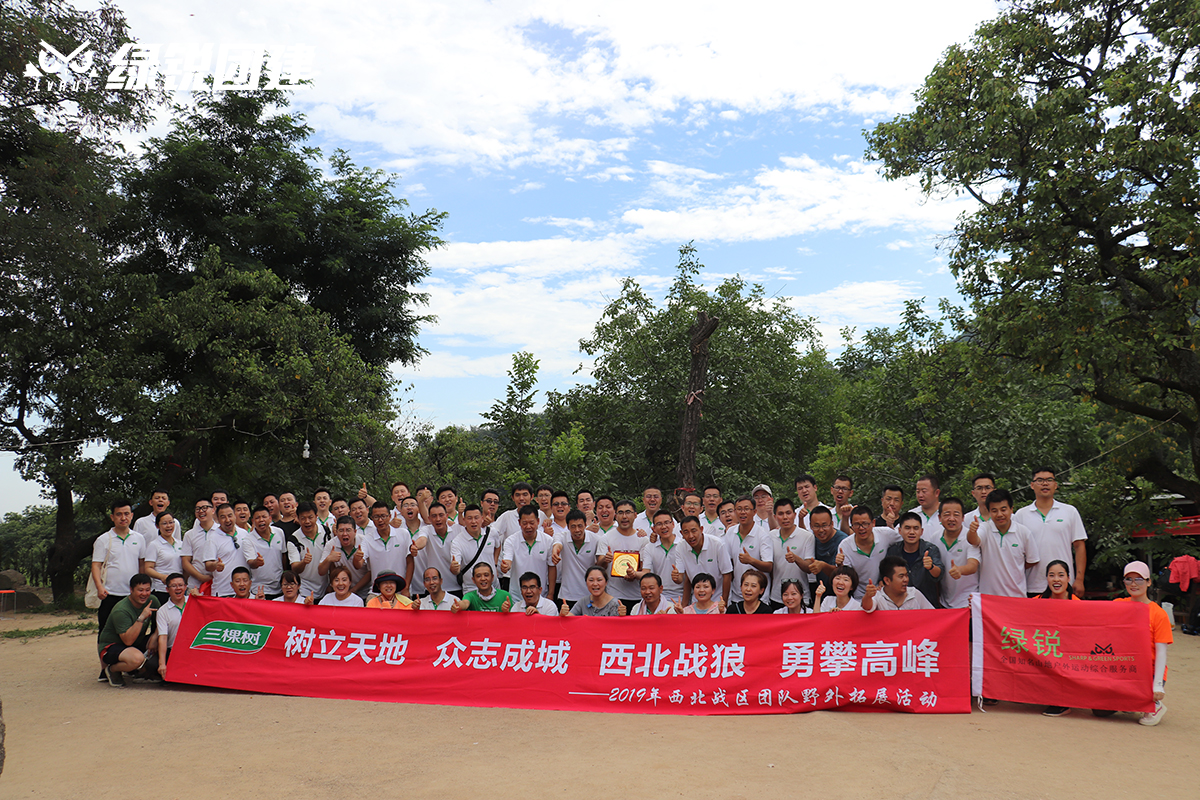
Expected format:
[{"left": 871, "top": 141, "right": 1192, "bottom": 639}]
[{"left": 167, "top": 597, "right": 971, "bottom": 715}]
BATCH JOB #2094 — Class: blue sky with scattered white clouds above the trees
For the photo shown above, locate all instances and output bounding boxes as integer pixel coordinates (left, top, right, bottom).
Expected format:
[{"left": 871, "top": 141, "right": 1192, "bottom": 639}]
[{"left": 0, "top": 0, "right": 997, "bottom": 512}]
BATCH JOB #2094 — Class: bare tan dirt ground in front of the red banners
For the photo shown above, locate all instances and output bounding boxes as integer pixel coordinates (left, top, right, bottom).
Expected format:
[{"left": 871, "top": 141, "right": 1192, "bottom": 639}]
[{"left": 0, "top": 614, "right": 1200, "bottom": 800}]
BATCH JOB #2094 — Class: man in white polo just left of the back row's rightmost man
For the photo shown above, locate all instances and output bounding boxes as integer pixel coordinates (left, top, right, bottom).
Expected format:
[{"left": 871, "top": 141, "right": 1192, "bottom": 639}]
[{"left": 967, "top": 489, "right": 1040, "bottom": 597}]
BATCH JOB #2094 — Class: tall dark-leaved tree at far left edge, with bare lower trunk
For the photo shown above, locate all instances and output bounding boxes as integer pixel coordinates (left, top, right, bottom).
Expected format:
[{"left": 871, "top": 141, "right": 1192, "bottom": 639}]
[{"left": 0, "top": 0, "right": 158, "bottom": 599}]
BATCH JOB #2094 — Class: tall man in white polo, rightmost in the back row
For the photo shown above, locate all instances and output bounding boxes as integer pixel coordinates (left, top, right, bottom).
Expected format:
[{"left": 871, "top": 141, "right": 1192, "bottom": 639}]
[{"left": 1013, "top": 467, "right": 1087, "bottom": 596}]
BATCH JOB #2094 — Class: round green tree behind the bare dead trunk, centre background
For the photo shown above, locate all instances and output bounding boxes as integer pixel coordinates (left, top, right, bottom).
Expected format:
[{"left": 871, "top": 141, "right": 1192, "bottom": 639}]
[{"left": 546, "top": 245, "right": 838, "bottom": 494}]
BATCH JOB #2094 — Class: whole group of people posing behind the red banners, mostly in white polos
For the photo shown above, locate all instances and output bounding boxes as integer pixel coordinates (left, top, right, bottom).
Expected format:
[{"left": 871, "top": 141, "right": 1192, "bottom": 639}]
[{"left": 91, "top": 468, "right": 1171, "bottom": 724}]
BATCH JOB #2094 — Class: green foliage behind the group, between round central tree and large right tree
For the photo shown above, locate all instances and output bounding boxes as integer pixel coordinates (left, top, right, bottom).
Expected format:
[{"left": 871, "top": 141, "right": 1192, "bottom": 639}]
[{"left": 814, "top": 301, "right": 1097, "bottom": 506}]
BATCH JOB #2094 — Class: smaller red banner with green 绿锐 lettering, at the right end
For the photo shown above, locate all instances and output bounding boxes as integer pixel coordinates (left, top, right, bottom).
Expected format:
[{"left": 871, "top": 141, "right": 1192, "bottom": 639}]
[{"left": 972, "top": 595, "right": 1154, "bottom": 711}]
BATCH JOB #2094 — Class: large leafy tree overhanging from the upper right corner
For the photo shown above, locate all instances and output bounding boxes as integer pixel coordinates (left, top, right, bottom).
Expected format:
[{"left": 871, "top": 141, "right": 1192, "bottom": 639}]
[{"left": 868, "top": 0, "right": 1200, "bottom": 501}]
